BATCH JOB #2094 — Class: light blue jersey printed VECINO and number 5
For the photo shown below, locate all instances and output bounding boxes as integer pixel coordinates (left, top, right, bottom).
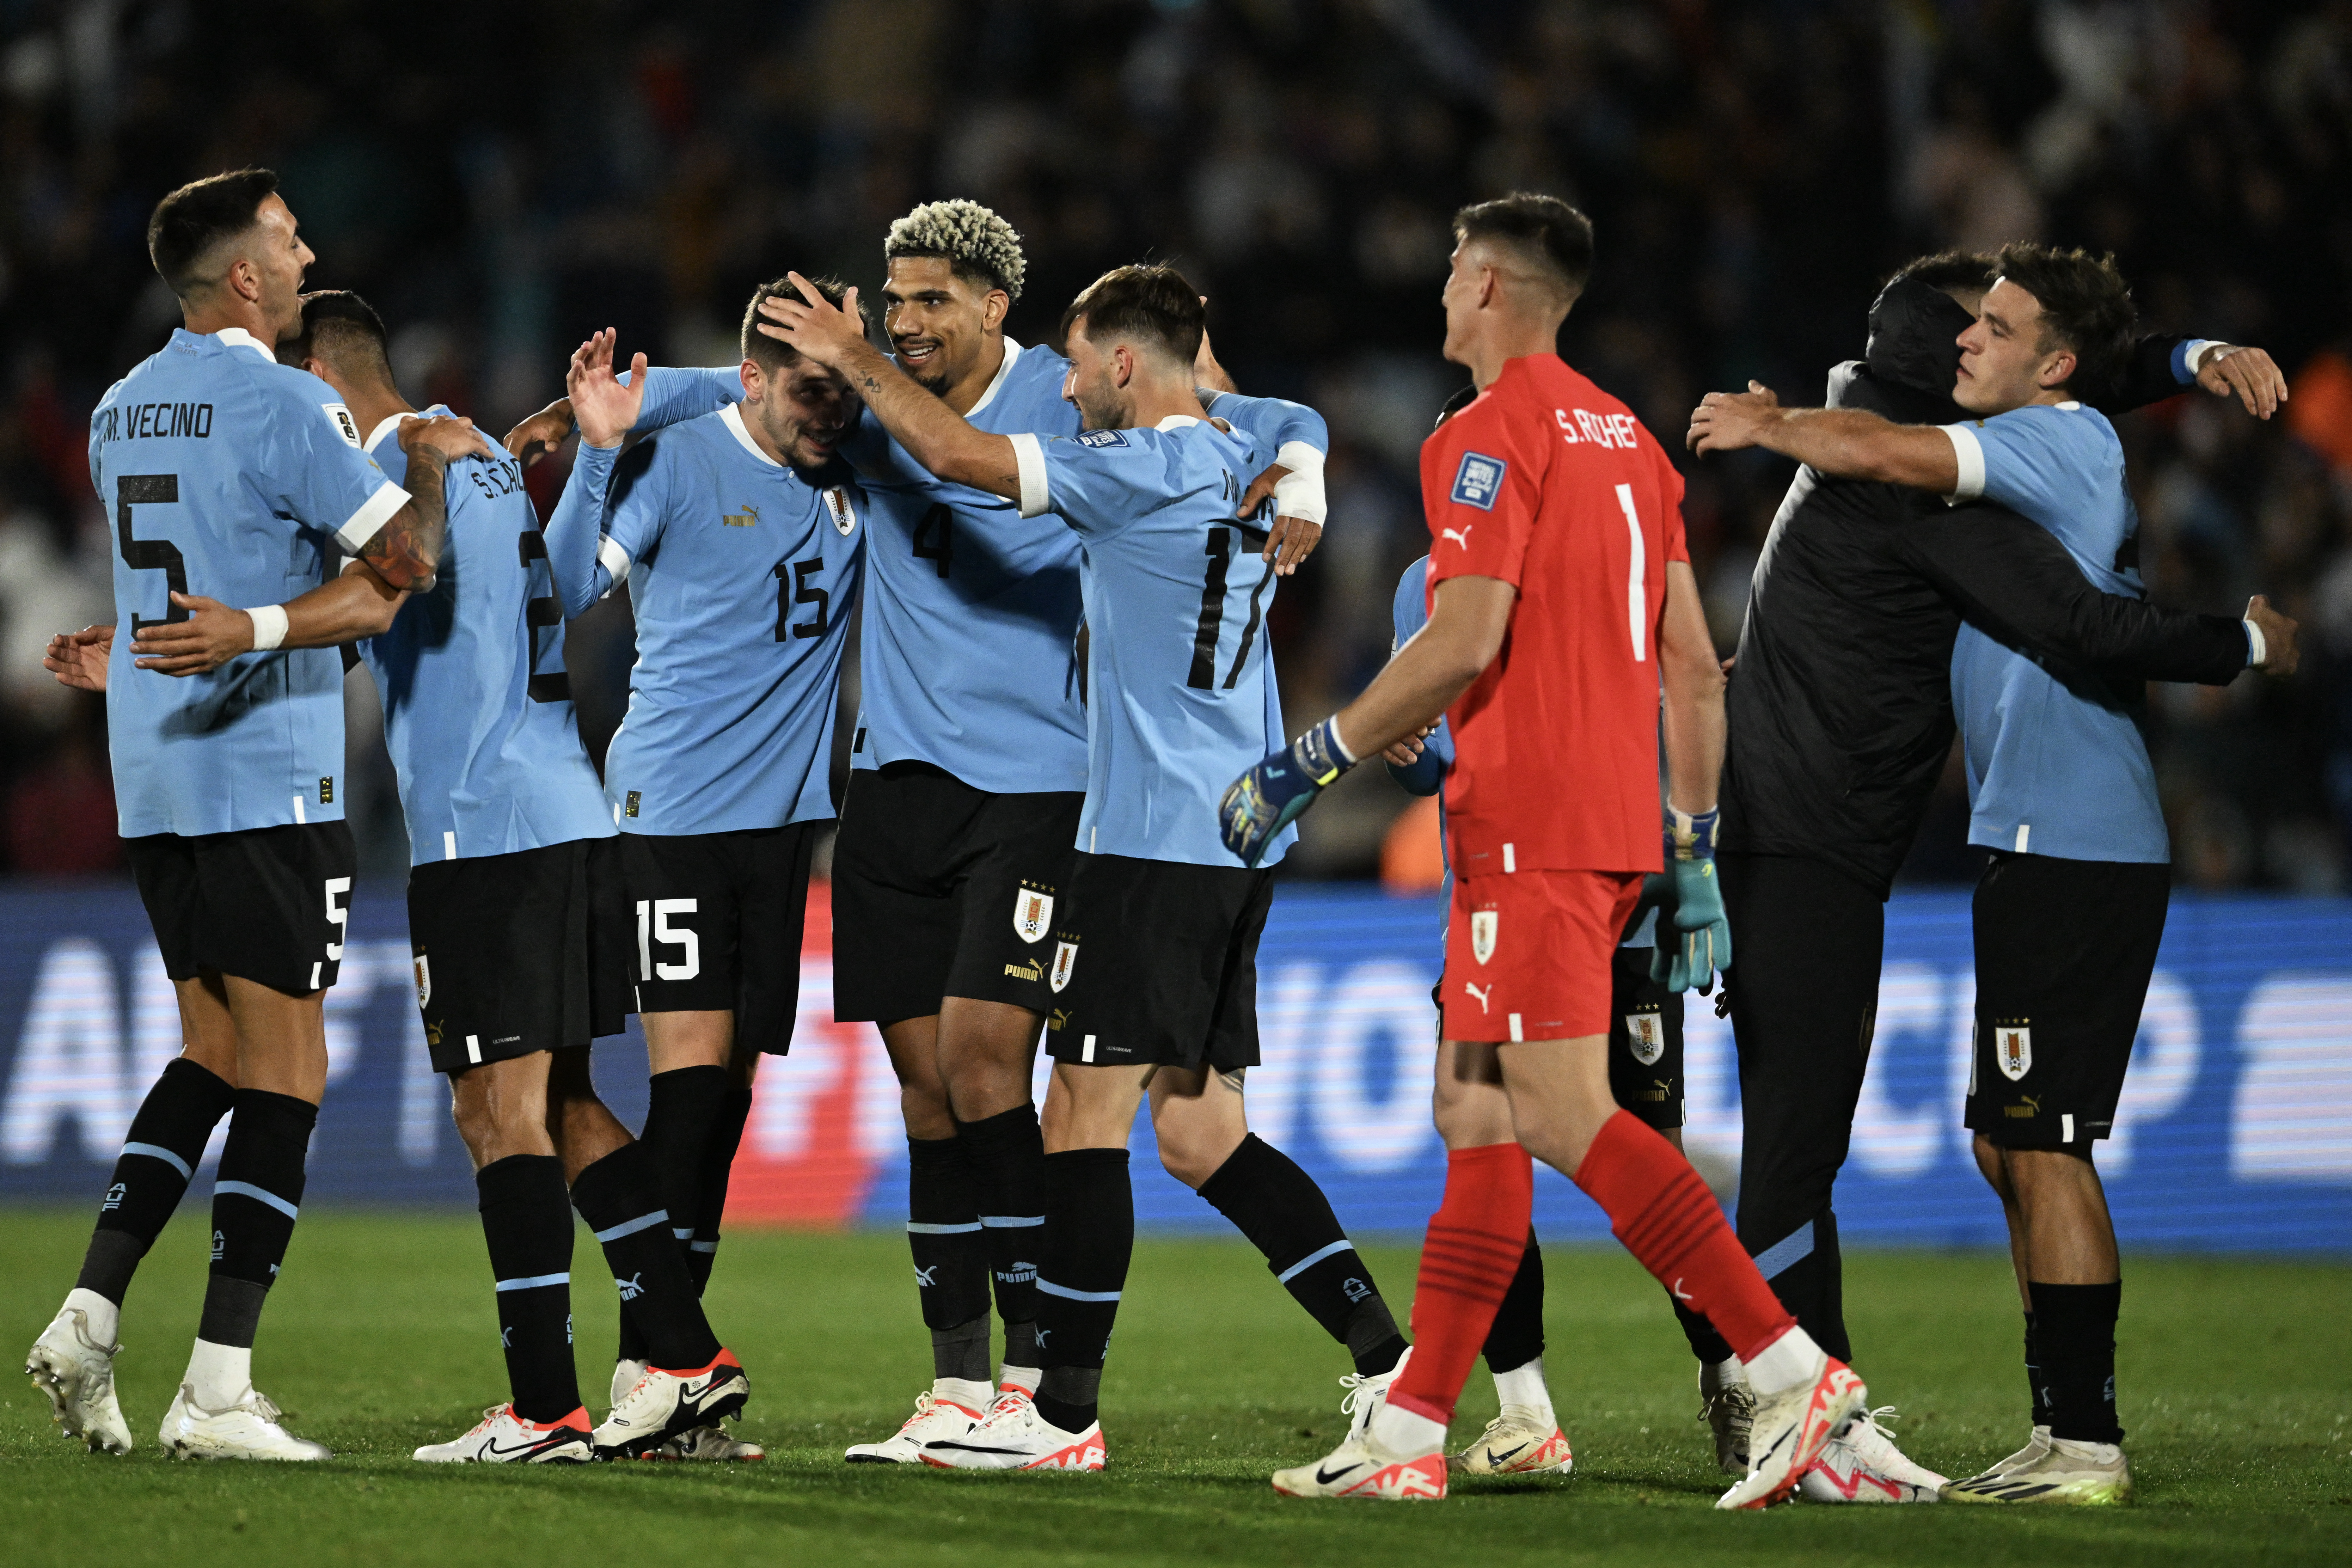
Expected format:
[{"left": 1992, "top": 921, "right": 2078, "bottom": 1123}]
[{"left": 90, "top": 327, "right": 409, "bottom": 839}]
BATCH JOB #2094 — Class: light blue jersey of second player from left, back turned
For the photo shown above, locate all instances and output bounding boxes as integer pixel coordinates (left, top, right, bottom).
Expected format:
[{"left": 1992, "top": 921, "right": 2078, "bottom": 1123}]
[{"left": 360, "top": 407, "right": 612, "bottom": 865}]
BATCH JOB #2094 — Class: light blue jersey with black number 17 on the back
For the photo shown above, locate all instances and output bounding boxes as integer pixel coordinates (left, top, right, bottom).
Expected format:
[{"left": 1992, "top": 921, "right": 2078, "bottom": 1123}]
[{"left": 1011, "top": 416, "right": 1298, "bottom": 868}]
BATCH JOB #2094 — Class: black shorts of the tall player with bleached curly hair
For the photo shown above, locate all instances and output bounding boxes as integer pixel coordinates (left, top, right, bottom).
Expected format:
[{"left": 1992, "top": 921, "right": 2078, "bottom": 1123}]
[{"left": 833, "top": 762, "right": 1086, "bottom": 1023}]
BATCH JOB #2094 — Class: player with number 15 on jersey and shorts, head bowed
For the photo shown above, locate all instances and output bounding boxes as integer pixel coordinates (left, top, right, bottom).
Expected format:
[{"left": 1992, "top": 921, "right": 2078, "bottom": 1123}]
[{"left": 546, "top": 284, "right": 865, "bottom": 1460}]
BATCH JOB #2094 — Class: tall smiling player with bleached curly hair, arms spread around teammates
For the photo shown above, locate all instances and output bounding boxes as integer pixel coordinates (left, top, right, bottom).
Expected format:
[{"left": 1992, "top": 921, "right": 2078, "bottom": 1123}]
[{"left": 522, "top": 200, "right": 1378, "bottom": 1465}]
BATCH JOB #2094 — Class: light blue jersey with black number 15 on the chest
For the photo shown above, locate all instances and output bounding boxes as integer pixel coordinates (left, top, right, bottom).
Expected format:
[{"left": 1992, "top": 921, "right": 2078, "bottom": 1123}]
[{"left": 548, "top": 407, "right": 865, "bottom": 834}]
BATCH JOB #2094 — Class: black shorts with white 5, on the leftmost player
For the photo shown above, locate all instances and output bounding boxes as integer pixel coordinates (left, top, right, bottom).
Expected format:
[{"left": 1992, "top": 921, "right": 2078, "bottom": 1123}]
[{"left": 125, "top": 823, "right": 360, "bottom": 997}]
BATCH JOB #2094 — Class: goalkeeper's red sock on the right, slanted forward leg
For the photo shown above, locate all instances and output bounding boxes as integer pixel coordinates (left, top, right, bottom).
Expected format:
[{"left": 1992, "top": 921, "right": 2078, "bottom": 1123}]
[{"left": 1571, "top": 1112, "right": 1797, "bottom": 1364}]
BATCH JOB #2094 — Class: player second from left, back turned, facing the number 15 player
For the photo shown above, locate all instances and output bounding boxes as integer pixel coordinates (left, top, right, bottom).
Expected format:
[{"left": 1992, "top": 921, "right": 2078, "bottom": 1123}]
[{"left": 280, "top": 292, "right": 746, "bottom": 1465}]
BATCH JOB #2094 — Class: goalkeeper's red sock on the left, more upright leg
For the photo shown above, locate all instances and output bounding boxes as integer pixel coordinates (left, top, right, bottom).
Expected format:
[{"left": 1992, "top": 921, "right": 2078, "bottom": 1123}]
[{"left": 1388, "top": 1143, "right": 1533, "bottom": 1427}]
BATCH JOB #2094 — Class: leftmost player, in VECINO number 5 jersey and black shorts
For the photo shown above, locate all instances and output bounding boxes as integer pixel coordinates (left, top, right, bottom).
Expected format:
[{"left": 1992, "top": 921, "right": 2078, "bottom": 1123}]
[{"left": 26, "top": 169, "right": 487, "bottom": 1460}]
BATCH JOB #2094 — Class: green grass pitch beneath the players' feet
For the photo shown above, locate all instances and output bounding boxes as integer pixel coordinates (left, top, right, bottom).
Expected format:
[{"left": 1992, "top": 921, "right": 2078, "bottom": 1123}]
[{"left": 0, "top": 1208, "right": 2352, "bottom": 1568}]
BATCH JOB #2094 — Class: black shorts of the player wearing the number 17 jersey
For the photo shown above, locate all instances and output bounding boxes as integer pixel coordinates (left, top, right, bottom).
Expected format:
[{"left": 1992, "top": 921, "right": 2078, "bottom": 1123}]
[{"left": 1044, "top": 853, "right": 1275, "bottom": 1072}]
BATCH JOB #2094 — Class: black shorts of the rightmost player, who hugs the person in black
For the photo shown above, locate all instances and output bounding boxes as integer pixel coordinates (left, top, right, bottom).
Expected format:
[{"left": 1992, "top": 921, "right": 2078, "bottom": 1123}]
[{"left": 1966, "top": 853, "right": 2173, "bottom": 1150}]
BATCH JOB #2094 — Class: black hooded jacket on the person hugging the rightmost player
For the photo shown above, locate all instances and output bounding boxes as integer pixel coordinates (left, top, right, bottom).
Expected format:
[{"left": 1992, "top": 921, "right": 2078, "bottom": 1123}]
[{"left": 1722, "top": 282, "right": 2246, "bottom": 898}]
